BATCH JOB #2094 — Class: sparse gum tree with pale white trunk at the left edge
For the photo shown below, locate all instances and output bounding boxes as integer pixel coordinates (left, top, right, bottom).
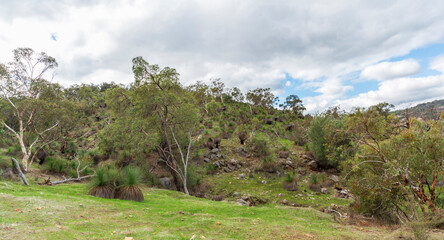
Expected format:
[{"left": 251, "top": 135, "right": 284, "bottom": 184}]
[{"left": 0, "top": 48, "right": 61, "bottom": 171}]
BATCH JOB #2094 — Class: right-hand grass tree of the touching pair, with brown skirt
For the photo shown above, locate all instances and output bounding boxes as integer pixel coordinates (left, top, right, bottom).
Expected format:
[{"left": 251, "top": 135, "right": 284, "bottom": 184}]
[{"left": 115, "top": 166, "right": 144, "bottom": 202}]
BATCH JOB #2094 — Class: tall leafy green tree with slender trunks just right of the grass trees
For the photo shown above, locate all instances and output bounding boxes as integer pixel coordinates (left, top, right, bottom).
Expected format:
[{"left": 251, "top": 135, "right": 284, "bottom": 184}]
[{"left": 132, "top": 57, "right": 199, "bottom": 194}]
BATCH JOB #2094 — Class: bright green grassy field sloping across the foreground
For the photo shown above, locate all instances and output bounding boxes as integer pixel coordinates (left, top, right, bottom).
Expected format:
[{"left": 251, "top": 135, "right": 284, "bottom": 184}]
[{"left": 0, "top": 181, "right": 439, "bottom": 239}]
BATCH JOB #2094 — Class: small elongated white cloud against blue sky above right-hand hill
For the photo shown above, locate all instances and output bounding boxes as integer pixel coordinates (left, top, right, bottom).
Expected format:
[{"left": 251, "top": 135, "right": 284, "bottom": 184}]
[{"left": 361, "top": 59, "right": 421, "bottom": 81}]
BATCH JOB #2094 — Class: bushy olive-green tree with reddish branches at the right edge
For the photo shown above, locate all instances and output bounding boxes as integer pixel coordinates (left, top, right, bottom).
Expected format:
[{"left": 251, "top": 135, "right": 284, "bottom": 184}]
[{"left": 345, "top": 106, "right": 444, "bottom": 223}]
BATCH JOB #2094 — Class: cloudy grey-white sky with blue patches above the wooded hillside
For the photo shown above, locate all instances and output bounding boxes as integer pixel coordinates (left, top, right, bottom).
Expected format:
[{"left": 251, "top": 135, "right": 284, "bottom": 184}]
[{"left": 0, "top": 0, "right": 444, "bottom": 113}]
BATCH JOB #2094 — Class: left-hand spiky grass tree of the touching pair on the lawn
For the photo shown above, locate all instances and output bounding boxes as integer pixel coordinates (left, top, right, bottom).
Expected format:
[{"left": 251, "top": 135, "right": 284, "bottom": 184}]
[{"left": 89, "top": 167, "right": 117, "bottom": 198}]
